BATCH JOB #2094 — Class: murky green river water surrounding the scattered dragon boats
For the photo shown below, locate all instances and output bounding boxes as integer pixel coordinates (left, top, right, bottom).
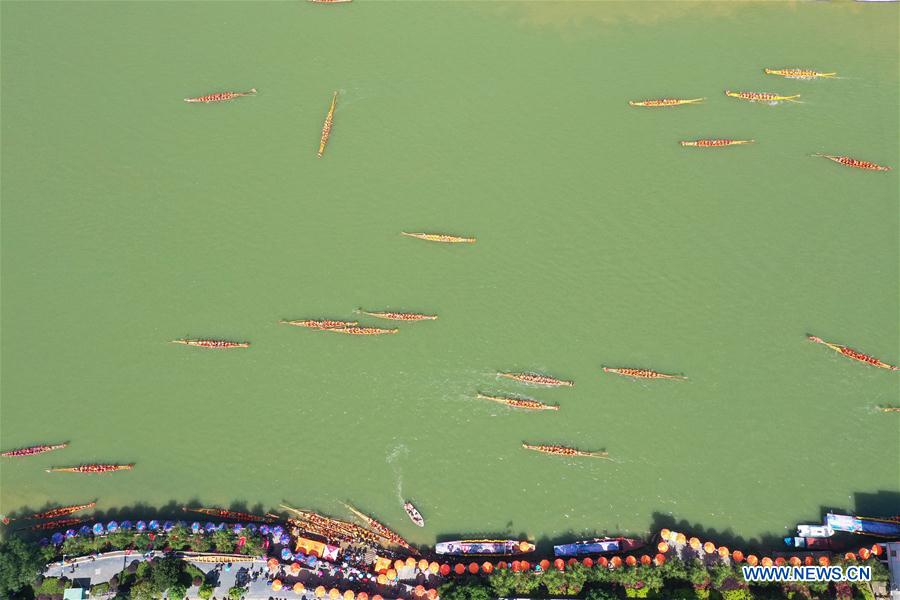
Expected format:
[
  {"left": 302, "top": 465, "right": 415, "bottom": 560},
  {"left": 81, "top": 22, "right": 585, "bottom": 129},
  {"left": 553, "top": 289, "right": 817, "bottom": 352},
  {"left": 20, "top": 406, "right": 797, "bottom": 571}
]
[{"left": 0, "top": 0, "right": 900, "bottom": 543}]
